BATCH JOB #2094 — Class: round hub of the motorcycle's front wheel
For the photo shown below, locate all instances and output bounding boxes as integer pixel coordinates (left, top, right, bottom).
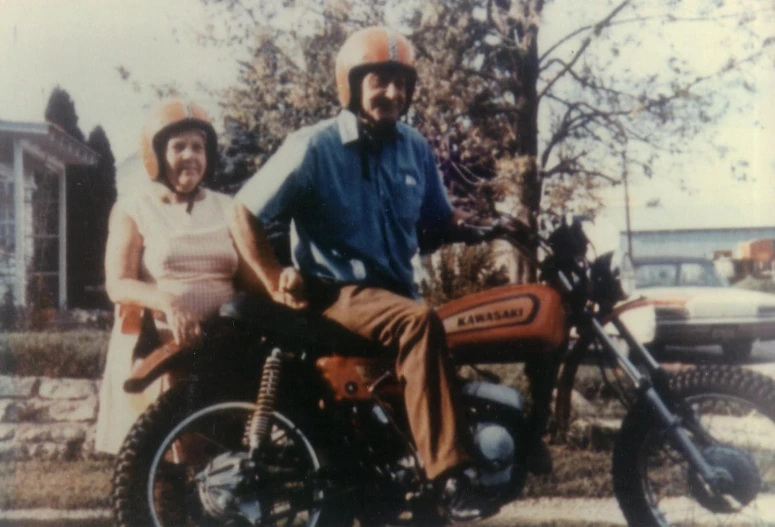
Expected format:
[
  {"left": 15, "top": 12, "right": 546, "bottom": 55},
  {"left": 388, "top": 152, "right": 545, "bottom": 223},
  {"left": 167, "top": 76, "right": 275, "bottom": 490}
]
[{"left": 688, "top": 445, "right": 762, "bottom": 513}]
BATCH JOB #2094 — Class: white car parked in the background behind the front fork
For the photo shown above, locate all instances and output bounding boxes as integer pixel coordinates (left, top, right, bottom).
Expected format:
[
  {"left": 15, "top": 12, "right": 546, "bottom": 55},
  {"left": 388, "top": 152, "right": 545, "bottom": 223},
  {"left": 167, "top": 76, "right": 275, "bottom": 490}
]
[{"left": 633, "top": 257, "right": 775, "bottom": 361}]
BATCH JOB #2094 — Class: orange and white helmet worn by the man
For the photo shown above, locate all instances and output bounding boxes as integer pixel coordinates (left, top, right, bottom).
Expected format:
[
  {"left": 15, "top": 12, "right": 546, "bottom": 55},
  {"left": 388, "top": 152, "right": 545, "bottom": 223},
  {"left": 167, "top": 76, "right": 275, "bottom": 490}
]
[{"left": 336, "top": 26, "right": 417, "bottom": 112}]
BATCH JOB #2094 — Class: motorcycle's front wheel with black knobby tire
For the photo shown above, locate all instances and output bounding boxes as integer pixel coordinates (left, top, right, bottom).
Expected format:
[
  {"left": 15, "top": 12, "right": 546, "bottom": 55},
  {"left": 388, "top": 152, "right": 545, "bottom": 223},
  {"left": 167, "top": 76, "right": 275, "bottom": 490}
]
[{"left": 613, "top": 366, "right": 775, "bottom": 527}]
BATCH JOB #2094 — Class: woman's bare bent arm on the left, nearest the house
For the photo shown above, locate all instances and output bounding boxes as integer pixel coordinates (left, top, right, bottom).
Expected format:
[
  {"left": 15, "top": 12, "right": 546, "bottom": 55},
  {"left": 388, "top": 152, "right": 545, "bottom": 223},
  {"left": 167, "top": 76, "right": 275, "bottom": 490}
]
[{"left": 105, "top": 205, "right": 201, "bottom": 344}]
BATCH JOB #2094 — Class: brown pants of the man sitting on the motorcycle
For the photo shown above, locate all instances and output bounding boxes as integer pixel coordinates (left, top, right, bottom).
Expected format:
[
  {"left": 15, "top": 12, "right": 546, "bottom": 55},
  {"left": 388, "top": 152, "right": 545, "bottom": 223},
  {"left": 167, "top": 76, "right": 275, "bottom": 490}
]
[{"left": 322, "top": 285, "right": 469, "bottom": 479}]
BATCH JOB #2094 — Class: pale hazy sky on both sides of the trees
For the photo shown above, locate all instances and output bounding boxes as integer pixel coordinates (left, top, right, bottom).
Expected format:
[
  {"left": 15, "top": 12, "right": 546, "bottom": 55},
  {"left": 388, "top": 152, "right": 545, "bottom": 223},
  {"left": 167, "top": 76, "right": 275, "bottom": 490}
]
[{"left": 0, "top": 0, "right": 775, "bottom": 235}]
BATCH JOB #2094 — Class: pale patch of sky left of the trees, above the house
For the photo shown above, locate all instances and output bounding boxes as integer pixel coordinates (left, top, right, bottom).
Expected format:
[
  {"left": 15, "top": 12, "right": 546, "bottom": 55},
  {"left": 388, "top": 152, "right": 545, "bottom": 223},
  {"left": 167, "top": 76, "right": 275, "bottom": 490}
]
[{"left": 0, "top": 0, "right": 236, "bottom": 161}]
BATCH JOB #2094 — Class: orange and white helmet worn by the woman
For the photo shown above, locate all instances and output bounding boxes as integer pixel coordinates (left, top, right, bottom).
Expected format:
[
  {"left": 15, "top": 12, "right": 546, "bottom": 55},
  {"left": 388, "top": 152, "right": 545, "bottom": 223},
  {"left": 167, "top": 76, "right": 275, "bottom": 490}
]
[{"left": 140, "top": 99, "right": 218, "bottom": 182}]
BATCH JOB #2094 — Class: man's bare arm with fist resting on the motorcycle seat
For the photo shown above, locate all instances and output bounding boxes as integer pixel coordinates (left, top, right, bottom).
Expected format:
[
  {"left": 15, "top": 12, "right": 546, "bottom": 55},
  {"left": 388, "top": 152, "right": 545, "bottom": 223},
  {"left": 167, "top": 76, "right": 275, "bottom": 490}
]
[{"left": 229, "top": 201, "right": 307, "bottom": 309}]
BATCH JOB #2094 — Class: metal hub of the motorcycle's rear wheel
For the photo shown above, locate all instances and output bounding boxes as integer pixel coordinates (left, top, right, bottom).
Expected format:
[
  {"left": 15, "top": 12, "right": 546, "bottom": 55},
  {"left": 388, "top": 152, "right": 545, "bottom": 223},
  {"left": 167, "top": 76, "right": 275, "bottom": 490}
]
[{"left": 196, "top": 452, "right": 262, "bottom": 525}]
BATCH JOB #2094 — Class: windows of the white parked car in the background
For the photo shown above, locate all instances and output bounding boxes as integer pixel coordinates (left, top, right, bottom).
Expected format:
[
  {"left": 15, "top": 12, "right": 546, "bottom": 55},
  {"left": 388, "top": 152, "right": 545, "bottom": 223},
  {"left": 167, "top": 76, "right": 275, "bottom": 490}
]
[{"left": 635, "top": 262, "right": 729, "bottom": 289}]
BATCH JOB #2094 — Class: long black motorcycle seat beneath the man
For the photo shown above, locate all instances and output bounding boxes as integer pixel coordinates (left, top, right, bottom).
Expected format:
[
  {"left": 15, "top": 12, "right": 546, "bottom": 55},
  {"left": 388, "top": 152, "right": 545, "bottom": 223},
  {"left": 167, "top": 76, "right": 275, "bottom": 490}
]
[{"left": 219, "top": 293, "right": 385, "bottom": 357}]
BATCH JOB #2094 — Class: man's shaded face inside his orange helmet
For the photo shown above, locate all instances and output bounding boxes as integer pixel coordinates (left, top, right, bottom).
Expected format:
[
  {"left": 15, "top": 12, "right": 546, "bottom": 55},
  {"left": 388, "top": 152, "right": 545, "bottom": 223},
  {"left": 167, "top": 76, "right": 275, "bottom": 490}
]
[{"left": 361, "top": 70, "right": 407, "bottom": 123}]
